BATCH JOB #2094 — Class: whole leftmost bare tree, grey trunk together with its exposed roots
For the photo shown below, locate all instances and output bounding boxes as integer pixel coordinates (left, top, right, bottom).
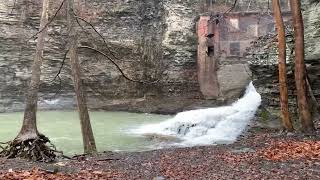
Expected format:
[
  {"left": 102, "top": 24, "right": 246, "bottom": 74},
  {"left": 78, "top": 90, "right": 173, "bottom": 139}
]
[{"left": 2, "top": 0, "right": 55, "bottom": 161}]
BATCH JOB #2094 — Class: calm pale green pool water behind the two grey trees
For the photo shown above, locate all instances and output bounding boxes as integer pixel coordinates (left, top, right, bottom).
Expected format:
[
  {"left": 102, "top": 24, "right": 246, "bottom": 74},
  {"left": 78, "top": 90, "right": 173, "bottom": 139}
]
[{"left": 0, "top": 111, "right": 170, "bottom": 155}]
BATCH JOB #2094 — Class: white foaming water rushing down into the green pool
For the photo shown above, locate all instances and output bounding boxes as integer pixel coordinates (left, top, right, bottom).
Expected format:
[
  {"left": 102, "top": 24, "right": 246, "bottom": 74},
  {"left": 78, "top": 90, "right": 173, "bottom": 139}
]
[{"left": 134, "top": 83, "right": 261, "bottom": 146}]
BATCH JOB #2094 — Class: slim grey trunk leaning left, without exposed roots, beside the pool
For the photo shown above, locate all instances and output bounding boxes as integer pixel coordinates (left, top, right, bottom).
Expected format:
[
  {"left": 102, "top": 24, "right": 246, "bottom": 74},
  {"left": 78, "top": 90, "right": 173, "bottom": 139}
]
[{"left": 67, "top": 0, "right": 97, "bottom": 154}]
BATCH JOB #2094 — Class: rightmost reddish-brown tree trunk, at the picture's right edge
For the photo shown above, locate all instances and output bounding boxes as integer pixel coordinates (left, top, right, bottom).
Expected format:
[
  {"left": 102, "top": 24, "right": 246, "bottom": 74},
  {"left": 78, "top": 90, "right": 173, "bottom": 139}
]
[{"left": 290, "top": 0, "right": 315, "bottom": 133}]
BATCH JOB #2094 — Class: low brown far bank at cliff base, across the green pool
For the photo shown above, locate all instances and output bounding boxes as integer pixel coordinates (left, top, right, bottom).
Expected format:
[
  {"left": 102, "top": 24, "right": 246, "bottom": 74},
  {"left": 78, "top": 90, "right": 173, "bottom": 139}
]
[{"left": 0, "top": 95, "right": 230, "bottom": 115}]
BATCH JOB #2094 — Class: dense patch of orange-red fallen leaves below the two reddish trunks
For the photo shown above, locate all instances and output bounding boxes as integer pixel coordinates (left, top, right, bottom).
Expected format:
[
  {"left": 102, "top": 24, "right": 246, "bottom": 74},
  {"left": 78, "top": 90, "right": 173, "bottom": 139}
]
[{"left": 260, "top": 140, "right": 320, "bottom": 161}]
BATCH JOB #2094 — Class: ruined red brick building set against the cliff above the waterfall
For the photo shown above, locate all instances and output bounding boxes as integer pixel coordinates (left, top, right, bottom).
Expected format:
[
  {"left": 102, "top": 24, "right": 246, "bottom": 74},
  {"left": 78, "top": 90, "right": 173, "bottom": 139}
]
[{"left": 197, "top": 0, "right": 290, "bottom": 99}]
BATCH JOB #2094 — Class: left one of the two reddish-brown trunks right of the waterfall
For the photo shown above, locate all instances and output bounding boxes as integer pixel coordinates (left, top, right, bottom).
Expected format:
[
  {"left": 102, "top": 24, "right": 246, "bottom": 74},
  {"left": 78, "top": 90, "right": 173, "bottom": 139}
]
[{"left": 272, "top": 0, "right": 293, "bottom": 131}]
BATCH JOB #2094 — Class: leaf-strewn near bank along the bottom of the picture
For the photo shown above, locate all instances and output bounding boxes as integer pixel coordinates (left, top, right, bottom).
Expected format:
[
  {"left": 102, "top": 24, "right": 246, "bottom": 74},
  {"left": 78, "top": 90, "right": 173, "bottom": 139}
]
[{"left": 0, "top": 128, "right": 320, "bottom": 180}]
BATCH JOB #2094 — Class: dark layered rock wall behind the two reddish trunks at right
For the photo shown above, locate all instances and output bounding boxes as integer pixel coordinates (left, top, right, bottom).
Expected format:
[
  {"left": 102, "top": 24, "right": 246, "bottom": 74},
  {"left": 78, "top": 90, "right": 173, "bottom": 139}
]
[{"left": 248, "top": 2, "right": 320, "bottom": 121}]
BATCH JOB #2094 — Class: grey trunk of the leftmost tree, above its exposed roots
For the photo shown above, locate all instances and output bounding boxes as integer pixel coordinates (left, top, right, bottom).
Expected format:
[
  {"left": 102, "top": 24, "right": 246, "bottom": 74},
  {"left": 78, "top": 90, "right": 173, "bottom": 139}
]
[{"left": 15, "top": 0, "right": 49, "bottom": 141}]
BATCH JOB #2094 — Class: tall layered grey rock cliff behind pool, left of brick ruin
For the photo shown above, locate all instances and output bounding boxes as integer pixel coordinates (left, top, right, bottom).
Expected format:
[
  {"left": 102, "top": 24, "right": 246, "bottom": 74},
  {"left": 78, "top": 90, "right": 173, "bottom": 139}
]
[{"left": 0, "top": 0, "right": 276, "bottom": 112}]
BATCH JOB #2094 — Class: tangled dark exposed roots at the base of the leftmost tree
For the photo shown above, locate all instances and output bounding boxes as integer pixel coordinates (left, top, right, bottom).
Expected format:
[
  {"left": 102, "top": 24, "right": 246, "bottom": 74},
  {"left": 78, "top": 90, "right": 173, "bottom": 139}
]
[{"left": 0, "top": 135, "right": 62, "bottom": 162}]
